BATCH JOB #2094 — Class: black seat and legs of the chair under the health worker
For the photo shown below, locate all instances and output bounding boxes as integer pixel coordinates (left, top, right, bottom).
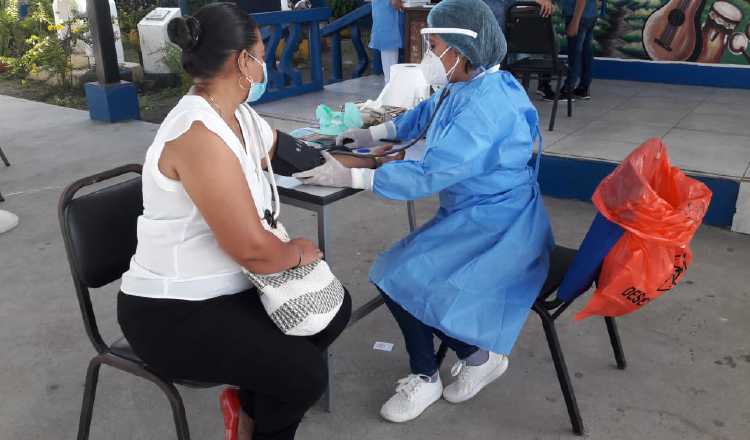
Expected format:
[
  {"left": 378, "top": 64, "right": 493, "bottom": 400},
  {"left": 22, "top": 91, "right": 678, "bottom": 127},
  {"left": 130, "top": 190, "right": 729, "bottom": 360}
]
[{"left": 438, "top": 246, "right": 626, "bottom": 435}]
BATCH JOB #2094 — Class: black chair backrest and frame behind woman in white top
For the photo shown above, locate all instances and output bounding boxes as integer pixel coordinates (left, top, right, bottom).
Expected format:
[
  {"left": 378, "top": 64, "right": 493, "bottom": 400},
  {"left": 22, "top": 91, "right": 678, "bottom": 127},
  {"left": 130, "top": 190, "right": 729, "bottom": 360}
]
[{"left": 58, "top": 165, "right": 143, "bottom": 353}]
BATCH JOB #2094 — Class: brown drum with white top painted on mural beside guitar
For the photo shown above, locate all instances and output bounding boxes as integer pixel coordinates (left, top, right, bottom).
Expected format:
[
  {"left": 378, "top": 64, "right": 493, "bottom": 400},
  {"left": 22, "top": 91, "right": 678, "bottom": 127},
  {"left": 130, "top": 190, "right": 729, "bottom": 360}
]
[{"left": 696, "top": 1, "right": 742, "bottom": 64}]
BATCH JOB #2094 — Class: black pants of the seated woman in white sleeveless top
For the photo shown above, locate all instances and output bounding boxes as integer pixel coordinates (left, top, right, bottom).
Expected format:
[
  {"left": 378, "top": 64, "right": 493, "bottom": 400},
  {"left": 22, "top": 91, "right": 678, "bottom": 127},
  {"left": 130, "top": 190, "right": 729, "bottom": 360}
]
[{"left": 117, "top": 289, "right": 351, "bottom": 440}]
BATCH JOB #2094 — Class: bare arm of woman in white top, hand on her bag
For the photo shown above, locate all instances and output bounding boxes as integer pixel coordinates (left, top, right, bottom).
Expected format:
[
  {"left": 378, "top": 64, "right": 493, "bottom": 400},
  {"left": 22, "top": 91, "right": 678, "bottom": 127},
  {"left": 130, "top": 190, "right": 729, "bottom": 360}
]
[{"left": 159, "top": 122, "right": 319, "bottom": 273}]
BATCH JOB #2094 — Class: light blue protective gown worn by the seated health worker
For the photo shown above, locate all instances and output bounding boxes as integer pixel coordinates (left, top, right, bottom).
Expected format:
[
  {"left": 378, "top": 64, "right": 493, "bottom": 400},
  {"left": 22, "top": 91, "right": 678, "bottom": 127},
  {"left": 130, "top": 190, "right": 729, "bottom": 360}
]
[{"left": 370, "top": 71, "right": 554, "bottom": 354}]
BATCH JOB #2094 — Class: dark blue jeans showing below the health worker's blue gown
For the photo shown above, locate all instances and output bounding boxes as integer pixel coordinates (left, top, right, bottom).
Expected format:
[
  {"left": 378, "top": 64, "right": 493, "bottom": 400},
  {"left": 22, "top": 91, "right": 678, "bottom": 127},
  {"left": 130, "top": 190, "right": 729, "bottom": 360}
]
[{"left": 380, "top": 290, "right": 479, "bottom": 376}]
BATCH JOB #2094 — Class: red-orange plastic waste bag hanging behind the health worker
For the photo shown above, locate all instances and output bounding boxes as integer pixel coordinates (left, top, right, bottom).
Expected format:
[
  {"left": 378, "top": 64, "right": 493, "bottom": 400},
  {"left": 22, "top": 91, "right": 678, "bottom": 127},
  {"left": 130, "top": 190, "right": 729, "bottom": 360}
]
[{"left": 576, "top": 139, "right": 711, "bottom": 319}]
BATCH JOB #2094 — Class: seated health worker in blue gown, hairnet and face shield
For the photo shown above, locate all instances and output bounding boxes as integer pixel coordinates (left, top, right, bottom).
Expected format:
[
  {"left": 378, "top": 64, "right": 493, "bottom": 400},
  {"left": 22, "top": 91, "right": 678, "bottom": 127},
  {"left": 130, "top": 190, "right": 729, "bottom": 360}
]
[{"left": 297, "top": 0, "right": 554, "bottom": 422}]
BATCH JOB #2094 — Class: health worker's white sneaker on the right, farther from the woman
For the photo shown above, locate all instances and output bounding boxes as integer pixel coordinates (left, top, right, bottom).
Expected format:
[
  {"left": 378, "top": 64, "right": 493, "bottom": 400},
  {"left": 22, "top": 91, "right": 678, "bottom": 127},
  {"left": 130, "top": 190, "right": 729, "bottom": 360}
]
[{"left": 443, "top": 352, "right": 508, "bottom": 403}]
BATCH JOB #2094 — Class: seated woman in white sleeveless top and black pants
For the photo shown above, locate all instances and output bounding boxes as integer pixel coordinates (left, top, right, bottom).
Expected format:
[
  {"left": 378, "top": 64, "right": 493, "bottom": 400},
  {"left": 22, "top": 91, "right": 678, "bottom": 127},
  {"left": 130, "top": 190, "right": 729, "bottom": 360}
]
[{"left": 117, "top": 3, "right": 351, "bottom": 440}]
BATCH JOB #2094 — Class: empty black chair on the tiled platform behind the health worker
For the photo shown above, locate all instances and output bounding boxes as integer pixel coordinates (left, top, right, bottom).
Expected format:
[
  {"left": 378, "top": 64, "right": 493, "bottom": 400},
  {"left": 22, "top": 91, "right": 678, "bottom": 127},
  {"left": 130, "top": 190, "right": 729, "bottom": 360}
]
[{"left": 503, "top": 2, "right": 573, "bottom": 131}]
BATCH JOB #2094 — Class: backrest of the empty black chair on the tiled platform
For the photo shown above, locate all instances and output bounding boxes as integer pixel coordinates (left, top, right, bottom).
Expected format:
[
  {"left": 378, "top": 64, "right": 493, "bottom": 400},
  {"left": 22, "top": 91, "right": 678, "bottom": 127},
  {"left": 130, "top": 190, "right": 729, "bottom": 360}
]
[{"left": 505, "top": 2, "right": 558, "bottom": 60}]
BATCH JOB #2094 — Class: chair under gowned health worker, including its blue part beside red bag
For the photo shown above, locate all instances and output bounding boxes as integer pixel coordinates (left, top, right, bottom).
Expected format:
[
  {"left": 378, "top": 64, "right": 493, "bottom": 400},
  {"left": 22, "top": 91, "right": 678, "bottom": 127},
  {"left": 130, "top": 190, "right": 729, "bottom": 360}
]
[{"left": 437, "top": 215, "right": 627, "bottom": 435}]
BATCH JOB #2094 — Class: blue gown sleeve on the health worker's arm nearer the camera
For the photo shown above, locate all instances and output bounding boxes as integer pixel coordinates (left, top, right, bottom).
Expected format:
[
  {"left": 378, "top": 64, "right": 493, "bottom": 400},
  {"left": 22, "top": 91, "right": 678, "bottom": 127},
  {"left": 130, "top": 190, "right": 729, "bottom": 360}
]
[{"left": 373, "top": 101, "right": 521, "bottom": 200}]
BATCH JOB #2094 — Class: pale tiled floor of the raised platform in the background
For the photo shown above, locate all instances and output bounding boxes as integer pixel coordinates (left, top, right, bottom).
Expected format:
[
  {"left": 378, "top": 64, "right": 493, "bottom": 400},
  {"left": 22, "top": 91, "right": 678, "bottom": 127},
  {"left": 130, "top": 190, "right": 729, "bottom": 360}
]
[{"left": 258, "top": 77, "right": 750, "bottom": 179}]
